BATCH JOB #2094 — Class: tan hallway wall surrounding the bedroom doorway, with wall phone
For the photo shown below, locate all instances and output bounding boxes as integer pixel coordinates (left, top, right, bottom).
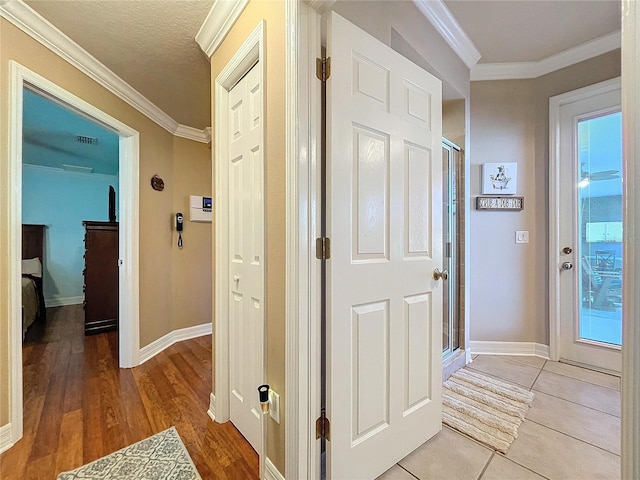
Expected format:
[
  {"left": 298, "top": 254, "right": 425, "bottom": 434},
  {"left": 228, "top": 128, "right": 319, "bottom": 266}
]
[{"left": 0, "top": 18, "right": 211, "bottom": 426}]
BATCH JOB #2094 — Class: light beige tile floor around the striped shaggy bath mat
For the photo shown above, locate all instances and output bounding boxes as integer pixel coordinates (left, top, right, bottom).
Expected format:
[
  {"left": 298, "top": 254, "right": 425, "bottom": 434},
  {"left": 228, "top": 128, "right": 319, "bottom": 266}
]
[{"left": 379, "top": 355, "right": 620, "bottom": 480}]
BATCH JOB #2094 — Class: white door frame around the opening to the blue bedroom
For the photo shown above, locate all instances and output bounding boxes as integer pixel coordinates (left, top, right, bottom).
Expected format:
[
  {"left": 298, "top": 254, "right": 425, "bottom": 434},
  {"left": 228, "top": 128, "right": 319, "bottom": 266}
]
[{"left": 5, "top": 61, "right": 140, "bottom": 448}]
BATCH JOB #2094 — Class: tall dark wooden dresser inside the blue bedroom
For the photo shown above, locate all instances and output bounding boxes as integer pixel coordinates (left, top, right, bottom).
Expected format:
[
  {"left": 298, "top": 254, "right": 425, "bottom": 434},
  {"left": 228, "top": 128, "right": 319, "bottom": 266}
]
[{"left": 82, "top": 220, "right": 119, "bottom": 335}]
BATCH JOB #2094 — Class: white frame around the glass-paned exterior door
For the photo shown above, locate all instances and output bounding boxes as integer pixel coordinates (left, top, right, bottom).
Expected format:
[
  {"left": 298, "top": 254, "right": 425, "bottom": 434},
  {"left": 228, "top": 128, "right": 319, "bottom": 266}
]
[{"left": 549, "top": 77, "right": 620, "bottom": 361}]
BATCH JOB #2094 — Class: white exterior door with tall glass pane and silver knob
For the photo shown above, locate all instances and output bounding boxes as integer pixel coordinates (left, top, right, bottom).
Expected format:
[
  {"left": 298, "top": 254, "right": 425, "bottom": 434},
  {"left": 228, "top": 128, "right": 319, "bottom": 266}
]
[{"left": 552, "top": 81, "right": 623, "bottom": 372}]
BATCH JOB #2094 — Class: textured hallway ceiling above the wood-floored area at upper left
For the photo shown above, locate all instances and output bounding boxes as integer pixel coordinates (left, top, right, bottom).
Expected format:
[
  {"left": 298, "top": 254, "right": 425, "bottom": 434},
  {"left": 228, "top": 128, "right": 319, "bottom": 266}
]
[{"left": 25, "top": 0, "right": 213, "bottom": 129}]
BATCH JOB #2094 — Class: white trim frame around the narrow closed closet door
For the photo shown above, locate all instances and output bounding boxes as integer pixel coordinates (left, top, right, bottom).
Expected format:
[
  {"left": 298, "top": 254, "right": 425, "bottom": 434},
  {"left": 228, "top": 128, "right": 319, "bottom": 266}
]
[{"left": 208, "top": 20, "right": 268, "bottom": 428}]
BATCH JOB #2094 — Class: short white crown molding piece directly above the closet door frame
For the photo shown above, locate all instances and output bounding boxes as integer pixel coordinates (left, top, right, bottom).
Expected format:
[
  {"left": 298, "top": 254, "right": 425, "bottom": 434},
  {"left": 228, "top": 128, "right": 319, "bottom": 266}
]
[{"left": 196, "top": 0, "right": 249, "bottom": 58}]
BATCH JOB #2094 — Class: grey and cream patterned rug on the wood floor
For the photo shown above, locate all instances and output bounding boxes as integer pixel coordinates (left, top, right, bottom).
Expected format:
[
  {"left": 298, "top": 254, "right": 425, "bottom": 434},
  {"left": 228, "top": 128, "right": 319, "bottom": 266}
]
[{"left": 58, "top": 427, "right": 201, "bottom": 480}]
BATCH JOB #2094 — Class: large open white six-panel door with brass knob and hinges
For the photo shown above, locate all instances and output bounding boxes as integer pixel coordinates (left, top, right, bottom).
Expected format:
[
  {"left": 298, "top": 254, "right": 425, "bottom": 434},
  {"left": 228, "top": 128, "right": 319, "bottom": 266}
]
[{"left": 327, "top": 12, "right": 443, "bottom": 479}]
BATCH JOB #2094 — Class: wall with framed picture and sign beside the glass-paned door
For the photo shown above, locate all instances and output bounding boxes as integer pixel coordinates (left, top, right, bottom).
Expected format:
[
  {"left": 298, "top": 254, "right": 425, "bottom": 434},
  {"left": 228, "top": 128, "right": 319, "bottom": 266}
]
[{"left": 468, "top": 50, "right": 620, "bottom": 345}]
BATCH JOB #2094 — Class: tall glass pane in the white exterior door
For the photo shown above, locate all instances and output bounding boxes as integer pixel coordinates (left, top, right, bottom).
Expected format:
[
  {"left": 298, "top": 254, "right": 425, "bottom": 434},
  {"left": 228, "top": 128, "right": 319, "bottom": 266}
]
[{"left": 577, "top": 112, "right": 623, "bottom": 346}]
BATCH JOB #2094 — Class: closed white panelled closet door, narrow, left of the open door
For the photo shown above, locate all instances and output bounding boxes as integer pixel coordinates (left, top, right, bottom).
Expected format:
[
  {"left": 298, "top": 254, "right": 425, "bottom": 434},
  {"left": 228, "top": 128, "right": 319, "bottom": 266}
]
[{"left": 228, "top": 62, "right": 264, "bottom": 452}]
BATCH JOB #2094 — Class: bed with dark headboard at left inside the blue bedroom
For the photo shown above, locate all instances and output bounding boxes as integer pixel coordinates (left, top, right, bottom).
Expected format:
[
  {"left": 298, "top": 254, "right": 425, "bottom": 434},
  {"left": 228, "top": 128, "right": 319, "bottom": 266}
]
[{"left": 21, "top": 224, "right": 46, "bottom": 339}]
